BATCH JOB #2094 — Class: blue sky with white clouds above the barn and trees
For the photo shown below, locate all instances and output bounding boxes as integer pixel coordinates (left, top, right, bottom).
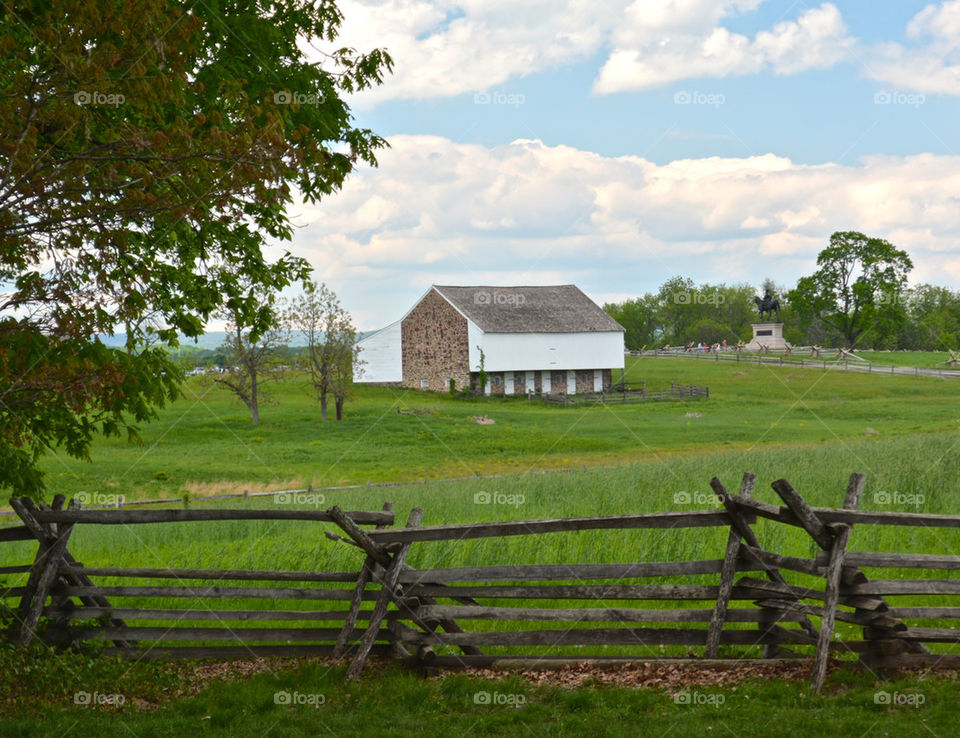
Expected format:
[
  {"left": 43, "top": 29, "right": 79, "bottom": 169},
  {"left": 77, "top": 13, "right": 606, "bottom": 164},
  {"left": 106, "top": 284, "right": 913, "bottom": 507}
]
[{"left": 284, "top": 0, "right": 960, "bottom": 330}]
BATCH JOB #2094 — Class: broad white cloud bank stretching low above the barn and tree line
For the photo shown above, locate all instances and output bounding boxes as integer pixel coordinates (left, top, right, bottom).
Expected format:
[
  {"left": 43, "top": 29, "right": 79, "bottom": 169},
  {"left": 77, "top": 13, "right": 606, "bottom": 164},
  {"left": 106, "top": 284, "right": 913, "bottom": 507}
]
[{"left": 294, "top": 136, "right": 960, "bottom": 329}]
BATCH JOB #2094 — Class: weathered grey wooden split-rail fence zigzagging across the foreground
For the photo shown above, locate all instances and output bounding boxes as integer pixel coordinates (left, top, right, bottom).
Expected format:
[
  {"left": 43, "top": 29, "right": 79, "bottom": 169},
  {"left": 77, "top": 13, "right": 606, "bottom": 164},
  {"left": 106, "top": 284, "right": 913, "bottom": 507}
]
[{"left": 0, "top": 473, "right": 960, "bottom": 690}]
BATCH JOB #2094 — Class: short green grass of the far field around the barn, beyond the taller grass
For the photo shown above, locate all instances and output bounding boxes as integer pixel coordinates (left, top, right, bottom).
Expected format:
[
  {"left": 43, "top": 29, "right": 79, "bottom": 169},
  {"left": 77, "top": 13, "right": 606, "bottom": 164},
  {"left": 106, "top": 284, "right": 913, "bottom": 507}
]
[{"left": 16, "top": 357, "right": 960, "bottom": 500}]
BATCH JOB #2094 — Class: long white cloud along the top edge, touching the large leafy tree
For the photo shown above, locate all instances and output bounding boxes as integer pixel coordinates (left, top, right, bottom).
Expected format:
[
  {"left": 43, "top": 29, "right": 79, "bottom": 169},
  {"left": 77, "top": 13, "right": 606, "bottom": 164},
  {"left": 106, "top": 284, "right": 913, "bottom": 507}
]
[{"left": 328, "top": 0, "right": 853, "bottom": 107}]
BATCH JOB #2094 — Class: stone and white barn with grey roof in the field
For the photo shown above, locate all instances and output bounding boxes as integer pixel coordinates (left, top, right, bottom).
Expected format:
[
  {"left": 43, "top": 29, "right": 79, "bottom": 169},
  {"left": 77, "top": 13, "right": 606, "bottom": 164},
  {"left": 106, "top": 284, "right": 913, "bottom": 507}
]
[{"left": 356, "top": 284, "right": 624, "bottom": 395}]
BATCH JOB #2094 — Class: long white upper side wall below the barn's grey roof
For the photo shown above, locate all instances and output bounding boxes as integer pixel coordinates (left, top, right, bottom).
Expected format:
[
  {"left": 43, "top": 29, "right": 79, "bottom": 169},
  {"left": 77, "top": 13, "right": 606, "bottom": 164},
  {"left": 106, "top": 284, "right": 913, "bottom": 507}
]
[{"left": 478, "top": 331, "right": 623, "bottom": 372}]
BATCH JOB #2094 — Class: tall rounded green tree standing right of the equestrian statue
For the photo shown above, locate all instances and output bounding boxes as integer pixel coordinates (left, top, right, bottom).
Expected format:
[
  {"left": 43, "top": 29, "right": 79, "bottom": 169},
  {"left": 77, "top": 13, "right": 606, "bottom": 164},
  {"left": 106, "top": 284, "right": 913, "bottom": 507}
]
[{"left": 789, "top": 231, "right": 913, "bottom": 348}]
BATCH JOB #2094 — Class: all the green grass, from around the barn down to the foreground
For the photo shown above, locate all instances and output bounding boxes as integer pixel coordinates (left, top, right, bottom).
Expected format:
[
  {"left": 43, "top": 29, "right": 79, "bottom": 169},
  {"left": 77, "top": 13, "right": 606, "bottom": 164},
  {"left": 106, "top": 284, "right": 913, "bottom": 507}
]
[{"left": 0, "top": 358, "right": 960, "bottom": 735}]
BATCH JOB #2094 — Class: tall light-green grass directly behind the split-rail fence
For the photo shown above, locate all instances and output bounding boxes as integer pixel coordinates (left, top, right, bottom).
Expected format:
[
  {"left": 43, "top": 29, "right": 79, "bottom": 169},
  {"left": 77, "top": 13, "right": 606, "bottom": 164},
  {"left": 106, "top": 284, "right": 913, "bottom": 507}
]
[{"left": 7, "top": 433, "right": 960, "bottom": 655}]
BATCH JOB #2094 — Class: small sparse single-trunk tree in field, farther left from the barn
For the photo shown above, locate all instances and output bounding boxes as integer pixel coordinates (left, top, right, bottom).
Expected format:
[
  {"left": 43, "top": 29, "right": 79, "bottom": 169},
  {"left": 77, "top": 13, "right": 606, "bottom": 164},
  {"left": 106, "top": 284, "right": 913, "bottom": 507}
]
[{"left": 213, "top": 294, "right": 286, "bottom": 425}]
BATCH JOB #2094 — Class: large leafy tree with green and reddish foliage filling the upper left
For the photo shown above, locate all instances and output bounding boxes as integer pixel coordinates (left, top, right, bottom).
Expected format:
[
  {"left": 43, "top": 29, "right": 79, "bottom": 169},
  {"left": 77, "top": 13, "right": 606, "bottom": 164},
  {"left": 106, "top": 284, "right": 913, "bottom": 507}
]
[{"left": 0, "top": 0, "right": 391, "bottom": 494}]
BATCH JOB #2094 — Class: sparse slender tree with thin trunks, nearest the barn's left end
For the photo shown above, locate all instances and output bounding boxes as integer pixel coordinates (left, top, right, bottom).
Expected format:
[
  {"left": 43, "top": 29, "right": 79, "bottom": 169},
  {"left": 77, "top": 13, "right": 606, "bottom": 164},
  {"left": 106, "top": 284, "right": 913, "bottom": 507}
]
[{"left": 286, "top": 281, "right": 359, "bottom": 420}]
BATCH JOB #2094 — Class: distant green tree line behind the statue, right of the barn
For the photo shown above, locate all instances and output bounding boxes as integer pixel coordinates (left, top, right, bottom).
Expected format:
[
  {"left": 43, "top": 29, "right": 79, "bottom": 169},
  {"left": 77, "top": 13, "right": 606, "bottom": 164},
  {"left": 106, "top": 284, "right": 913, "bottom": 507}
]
[{"left": 604, "top": 232, "right": 960, "bottom": 351}]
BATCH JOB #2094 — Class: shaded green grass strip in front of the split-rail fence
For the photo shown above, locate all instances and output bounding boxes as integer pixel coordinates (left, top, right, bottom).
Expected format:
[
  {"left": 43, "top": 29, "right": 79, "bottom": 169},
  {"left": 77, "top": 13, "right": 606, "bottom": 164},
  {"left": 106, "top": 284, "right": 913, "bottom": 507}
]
[{"left": 0, "top": 648, "right": 957, "bottom": 737}]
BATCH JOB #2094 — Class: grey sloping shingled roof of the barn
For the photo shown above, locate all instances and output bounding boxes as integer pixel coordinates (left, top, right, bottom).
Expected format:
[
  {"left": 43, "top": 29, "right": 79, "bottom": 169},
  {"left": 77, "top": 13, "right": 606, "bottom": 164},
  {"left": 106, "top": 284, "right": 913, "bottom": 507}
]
[{"left": 433, "top": 284, "right": 623, "bottom": 333}]
